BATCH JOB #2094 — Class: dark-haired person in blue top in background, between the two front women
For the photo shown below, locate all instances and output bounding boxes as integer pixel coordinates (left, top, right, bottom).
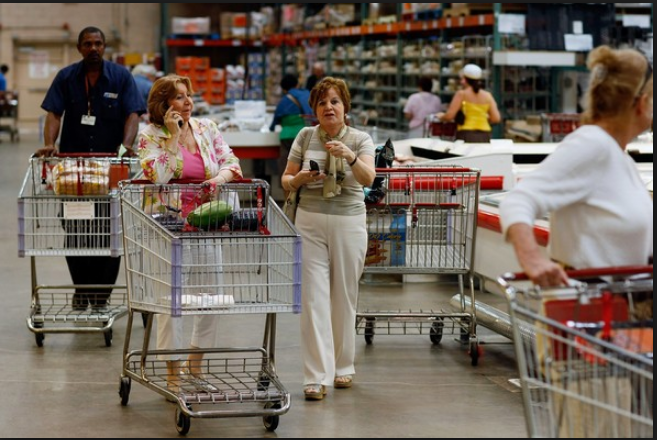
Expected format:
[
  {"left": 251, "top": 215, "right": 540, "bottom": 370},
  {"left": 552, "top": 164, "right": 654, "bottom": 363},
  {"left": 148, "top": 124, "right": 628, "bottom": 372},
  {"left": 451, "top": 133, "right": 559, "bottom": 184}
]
[{"left": 269, "top": 74, "right": 313, "bottom": 194}]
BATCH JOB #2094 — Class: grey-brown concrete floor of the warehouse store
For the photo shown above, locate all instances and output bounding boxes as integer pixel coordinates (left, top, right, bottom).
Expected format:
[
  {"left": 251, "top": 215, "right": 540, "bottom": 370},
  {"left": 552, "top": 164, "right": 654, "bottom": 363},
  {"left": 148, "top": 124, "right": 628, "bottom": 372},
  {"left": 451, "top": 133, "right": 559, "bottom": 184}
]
[{"left": 0, "top": 133, "right": 526, "bottom": 438}]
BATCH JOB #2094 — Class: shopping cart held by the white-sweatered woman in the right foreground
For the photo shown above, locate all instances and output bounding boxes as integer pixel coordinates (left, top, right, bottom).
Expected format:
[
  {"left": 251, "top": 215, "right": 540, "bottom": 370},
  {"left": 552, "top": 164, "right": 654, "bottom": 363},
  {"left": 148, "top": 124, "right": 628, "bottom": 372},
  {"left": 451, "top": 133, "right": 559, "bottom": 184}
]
[{"left": 499, "top": 266, "right": 653, "bottom": 438}]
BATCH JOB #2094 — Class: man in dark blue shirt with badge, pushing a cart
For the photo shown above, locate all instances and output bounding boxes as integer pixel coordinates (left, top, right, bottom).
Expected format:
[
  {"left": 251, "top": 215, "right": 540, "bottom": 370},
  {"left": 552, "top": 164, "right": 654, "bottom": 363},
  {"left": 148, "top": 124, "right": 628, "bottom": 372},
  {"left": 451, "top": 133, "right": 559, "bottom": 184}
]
[{"left": 36, "top": 26, "right": 146, "bottom": 311}]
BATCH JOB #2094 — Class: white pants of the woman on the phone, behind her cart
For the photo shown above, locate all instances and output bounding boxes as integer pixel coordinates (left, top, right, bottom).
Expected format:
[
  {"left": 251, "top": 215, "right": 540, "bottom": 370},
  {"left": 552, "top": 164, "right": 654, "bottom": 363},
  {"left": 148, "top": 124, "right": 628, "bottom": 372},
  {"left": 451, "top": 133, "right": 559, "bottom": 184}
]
[{"left": 156, "top": 240, "right": 223, "bottom": 360}]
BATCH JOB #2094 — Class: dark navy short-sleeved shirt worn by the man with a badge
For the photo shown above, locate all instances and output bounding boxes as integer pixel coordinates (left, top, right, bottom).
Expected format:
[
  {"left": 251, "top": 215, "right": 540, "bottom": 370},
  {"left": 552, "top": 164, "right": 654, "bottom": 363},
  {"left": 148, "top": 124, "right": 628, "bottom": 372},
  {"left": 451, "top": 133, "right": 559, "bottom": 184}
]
[{"left": 41, "top": 61, "right": 146, "bottom": 153}]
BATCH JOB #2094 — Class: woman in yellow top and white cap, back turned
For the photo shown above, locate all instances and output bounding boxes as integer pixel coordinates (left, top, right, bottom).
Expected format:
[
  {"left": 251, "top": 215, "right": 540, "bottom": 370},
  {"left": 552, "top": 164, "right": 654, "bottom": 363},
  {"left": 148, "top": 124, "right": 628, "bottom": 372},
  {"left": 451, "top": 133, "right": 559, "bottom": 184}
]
[{"left": 437, "top": 64, "right": 501, "bottom": 143}]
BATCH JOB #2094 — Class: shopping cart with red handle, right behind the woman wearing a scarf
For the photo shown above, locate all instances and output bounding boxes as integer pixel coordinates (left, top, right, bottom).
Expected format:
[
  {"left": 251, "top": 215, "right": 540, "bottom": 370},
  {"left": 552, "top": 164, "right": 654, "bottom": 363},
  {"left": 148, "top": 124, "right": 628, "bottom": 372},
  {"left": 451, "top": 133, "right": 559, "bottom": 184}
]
[{"left": 356, "top": 166, "right": 480, "bottom": 365}]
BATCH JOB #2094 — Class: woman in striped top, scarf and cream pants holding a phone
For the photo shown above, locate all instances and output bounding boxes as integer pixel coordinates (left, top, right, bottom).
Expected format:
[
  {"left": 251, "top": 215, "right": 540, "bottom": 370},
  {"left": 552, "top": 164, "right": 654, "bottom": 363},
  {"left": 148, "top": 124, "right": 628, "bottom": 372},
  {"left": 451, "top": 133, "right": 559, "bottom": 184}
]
[{"left": 282, "top": 77, "right": 375, "bottom": 400}]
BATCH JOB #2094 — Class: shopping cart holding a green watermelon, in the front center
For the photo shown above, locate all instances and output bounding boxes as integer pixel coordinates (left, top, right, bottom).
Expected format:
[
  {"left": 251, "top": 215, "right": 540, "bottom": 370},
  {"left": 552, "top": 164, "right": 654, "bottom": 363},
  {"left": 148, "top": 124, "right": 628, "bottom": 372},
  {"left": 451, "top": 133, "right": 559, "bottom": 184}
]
[{"left": 119, "top": 180, "right": 301, "bottom": 435}]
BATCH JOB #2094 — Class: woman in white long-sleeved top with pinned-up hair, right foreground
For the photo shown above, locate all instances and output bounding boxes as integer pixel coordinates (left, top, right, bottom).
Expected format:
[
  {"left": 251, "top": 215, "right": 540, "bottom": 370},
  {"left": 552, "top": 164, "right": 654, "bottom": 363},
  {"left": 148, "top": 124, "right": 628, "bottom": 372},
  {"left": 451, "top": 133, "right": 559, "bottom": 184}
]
[{"left": 500, "top": 46, "right": 653, "bottom": 286}]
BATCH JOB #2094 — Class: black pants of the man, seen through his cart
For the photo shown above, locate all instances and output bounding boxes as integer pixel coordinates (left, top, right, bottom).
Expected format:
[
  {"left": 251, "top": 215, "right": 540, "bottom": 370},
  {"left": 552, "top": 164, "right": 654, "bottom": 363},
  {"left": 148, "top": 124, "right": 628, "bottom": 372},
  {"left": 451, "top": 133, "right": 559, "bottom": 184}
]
[{"left": 62, "top": 202, "right": 121, "bottom": 310}]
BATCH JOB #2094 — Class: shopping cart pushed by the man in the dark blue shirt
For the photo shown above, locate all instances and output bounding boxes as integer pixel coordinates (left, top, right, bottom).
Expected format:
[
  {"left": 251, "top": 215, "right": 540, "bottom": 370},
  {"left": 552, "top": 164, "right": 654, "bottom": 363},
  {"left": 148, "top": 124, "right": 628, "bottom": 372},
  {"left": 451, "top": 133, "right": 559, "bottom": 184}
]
[{"left": 18, "top": 154, "right": 141, "bottom": 347}]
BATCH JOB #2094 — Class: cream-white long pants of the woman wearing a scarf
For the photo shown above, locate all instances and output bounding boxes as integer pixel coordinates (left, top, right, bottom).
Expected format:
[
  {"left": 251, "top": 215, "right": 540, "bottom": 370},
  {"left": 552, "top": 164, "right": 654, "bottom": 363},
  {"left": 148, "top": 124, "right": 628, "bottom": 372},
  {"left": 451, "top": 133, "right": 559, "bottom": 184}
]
[{"left": 295, "top": 209, "right": 367, "bottom": 385}]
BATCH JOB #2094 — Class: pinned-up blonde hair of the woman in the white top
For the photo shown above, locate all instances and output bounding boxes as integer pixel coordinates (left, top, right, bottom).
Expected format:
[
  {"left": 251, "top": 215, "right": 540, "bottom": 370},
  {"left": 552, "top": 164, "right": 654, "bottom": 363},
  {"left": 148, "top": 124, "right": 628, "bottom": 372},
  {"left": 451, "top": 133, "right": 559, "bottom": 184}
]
[{"left": 582, "top": 45, "right": 652, "bottom": 123}]
